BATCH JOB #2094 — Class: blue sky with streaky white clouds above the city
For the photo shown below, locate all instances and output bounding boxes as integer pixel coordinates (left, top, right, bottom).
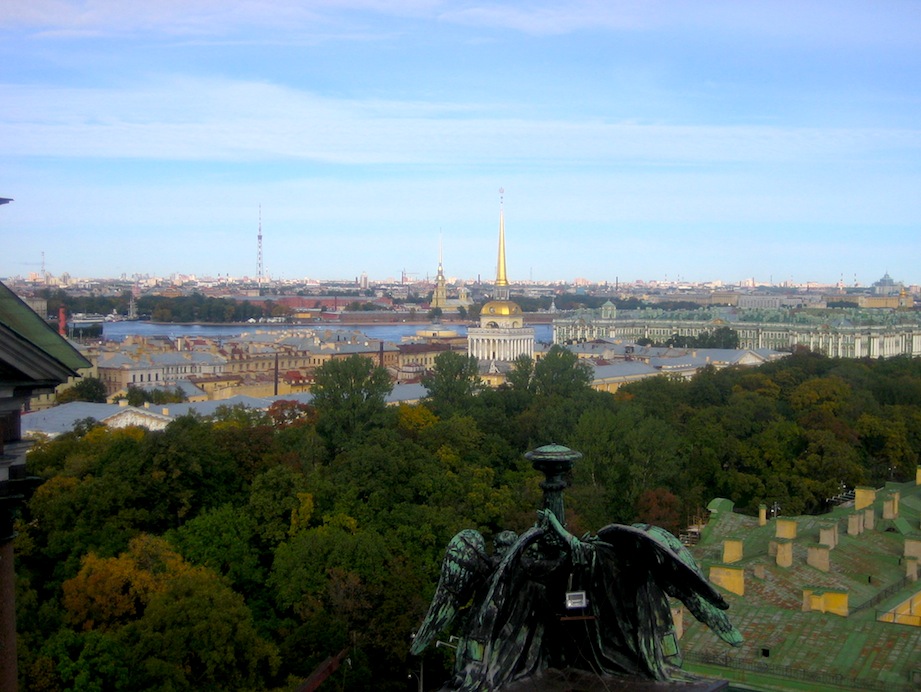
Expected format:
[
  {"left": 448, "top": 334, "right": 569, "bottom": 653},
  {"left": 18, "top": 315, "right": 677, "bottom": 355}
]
[{"left": 0, "top": 0, "right": 921, "bottom": 285}]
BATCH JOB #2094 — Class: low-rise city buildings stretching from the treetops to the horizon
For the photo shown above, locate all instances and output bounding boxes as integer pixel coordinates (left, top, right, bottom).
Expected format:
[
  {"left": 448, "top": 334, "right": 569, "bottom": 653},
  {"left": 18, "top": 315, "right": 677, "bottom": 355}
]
[{"left": 5, "top": 262, "right": 921, "bottom": 409}]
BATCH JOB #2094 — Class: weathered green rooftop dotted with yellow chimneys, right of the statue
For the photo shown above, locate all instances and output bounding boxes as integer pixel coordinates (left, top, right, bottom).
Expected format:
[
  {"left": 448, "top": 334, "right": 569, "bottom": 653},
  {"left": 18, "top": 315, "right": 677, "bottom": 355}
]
[{"left": 681, "top": 472, "right": 921, "bottom": 691}]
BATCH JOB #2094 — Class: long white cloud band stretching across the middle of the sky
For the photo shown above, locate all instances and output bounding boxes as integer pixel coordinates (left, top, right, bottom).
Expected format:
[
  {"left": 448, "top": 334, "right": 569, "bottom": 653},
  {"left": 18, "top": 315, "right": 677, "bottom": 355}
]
[{"left": 0, "top": 79, "right": 921, "bottom": 166}]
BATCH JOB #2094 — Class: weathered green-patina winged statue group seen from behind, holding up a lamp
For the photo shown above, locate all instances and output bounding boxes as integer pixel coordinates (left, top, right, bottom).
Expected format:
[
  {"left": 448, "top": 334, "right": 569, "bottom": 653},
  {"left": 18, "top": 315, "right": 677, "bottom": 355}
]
[{"left": 412, "top": 445, "right": 742, "bottom": 692}]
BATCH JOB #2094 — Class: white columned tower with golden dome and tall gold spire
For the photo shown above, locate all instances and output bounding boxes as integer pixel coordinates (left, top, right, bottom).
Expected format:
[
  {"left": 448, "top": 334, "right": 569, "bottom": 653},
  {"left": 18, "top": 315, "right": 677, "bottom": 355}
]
[{"left": 467, "top": 191, "right": 534, "bottom": 370}]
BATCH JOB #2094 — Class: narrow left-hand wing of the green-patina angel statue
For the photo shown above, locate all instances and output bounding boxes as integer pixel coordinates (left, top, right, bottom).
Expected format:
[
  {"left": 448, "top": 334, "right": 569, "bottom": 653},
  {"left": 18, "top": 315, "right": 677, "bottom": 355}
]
[{"left": 410, "top": 529, "right": 490, "bottom": 656}]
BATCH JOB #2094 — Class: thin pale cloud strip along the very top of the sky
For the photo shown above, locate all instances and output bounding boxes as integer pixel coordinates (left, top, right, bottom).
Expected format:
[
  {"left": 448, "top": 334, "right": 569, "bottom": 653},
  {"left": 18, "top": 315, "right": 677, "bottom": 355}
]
[{"left": 7, "top": 0, "right": 921, "bottom": 47}]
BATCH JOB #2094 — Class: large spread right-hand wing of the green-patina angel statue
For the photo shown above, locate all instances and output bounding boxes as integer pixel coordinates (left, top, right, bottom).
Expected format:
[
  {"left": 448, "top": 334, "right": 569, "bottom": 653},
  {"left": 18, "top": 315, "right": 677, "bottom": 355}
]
[{"left": 598, "top": 524, "right": 742, "bottom": 646}]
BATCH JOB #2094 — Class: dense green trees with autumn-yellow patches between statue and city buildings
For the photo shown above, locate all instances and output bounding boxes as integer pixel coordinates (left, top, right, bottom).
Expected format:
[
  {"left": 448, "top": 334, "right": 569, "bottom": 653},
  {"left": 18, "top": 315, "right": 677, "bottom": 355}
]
[{"left": 16, "top": 349, "right": 921, "bottom": 691}]
